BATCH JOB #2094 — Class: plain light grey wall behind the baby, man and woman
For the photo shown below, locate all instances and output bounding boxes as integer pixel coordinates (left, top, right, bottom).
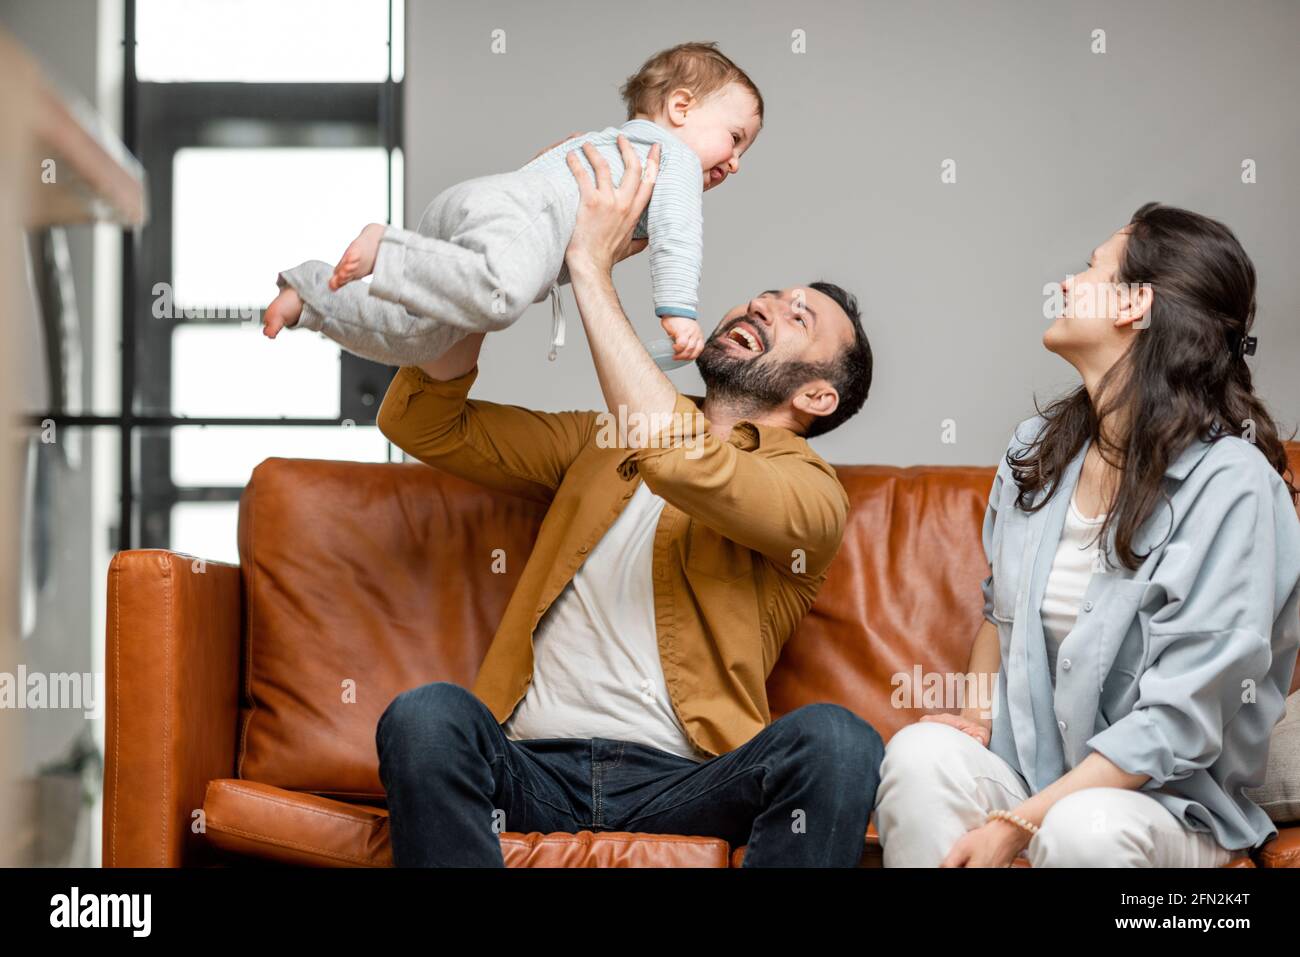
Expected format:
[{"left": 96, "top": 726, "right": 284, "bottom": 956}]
[{"left": 406, "top": 0, "right": 1300, "bottom": 464}]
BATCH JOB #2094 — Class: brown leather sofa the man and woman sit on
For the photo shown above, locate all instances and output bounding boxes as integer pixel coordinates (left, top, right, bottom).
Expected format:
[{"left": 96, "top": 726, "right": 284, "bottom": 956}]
[{"left": 103, "top": 445, "right": 1300, "bottom": 867}]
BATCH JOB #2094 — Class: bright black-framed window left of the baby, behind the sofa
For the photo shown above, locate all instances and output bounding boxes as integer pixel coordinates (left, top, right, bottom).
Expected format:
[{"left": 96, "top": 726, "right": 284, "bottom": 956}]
[{"left": 116, "top": 0, "right": 403, "bottom": 560}]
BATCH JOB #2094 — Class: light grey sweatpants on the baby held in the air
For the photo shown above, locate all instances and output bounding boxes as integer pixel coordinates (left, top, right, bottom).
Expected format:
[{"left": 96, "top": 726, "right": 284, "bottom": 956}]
[{"left": 277, "top": 170, "right": 573, "bottom": 365}]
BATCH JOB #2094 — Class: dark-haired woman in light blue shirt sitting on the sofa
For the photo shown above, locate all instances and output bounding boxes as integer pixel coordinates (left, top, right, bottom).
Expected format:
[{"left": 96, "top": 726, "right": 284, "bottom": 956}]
[{"left": 876, "top": 203, "right": 1300, "bottom": 867}]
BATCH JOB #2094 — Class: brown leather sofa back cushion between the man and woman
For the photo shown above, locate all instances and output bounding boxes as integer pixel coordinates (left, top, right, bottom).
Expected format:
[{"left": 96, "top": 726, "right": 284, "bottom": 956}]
[{"left": 767, "top": 465, "right": 995, "bottom": 740}]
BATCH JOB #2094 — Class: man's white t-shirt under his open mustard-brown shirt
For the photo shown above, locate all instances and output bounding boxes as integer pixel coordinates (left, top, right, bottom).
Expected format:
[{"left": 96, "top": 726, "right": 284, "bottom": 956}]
[{"left": 502, "top": 482, "right": 710, "bottom": 761}]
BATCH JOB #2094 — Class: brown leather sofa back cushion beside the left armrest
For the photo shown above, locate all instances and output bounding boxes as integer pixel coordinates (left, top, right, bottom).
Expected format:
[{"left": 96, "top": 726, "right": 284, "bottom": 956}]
[{"left": 238, "top": 458, "right": 545, "bottom": 798}]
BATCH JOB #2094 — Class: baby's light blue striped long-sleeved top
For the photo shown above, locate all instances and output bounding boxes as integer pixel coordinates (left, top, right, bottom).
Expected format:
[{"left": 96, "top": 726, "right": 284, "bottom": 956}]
[{"left": 523, "top": 120, "right": 705, "bottom": 319}]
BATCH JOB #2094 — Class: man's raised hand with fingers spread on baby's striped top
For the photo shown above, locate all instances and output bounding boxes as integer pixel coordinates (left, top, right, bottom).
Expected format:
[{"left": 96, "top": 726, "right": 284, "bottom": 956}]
[{"left": 564, "top": 134, "right": 659, "bottom": 276}]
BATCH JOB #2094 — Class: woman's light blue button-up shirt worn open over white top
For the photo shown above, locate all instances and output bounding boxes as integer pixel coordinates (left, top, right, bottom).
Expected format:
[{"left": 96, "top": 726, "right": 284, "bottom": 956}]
[{"left": 983, "top": 416, "right": 1300, "bottom": 850}]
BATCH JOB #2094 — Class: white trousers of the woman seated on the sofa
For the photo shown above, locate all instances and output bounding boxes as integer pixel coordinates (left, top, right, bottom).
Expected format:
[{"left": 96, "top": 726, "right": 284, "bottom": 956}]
[{"left": 875, "top": 722, "right": 1248, "bottom": 867}]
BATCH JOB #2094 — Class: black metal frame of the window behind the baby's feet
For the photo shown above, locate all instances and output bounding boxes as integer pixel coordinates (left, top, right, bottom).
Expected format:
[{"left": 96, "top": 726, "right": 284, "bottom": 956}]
[{"left": 29, "top": 0, "right": 403, "bottom": 551}]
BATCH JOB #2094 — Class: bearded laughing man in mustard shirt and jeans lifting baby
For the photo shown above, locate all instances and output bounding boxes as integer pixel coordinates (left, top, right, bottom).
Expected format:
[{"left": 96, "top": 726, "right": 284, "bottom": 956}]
[{"left": 376, "top": 138, "right": 883, "bottom": 867}]
